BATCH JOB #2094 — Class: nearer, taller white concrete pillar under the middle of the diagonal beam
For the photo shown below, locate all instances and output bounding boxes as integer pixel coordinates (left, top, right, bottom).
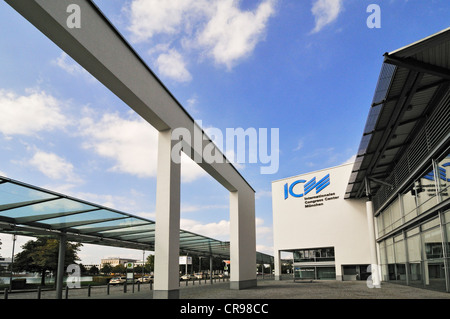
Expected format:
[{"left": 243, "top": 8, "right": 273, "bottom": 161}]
[{"left": 153, "top": 130, "right": 180, "bottom": 299}]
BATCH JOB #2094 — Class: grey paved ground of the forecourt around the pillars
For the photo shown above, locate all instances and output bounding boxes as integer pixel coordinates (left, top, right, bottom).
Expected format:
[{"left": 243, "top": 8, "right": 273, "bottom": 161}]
[{"left": 4, "top": 279, "right": 450, "bottom": 300}]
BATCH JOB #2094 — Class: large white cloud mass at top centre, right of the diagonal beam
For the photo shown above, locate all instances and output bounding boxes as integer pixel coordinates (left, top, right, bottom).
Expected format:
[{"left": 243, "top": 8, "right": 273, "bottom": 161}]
[{"left": 124, "top": 0, "right": 276, "bottom": 76}]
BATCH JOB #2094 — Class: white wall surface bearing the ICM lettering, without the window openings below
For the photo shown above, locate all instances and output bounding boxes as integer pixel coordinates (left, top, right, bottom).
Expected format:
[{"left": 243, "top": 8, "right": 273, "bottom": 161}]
[{"left": 272, "top": 163, "right": 370, "bottom": 278}]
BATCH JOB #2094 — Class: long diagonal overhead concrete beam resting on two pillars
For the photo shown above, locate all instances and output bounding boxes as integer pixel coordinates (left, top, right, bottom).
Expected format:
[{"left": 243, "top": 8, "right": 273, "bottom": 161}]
[{"left": 5, "top": 0, "right": 251, "bottom": 195}]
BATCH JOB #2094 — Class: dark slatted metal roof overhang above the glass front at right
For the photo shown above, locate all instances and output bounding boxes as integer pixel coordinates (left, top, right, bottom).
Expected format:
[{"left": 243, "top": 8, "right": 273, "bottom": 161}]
[{"left": 345, "top": 28, "right": 450, "bottom": 198}]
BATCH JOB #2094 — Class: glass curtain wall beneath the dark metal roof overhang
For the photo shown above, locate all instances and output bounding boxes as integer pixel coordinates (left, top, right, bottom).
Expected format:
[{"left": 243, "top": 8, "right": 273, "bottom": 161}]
[{"left": 376, "top": 151, "right": 450, "bottom": 292}]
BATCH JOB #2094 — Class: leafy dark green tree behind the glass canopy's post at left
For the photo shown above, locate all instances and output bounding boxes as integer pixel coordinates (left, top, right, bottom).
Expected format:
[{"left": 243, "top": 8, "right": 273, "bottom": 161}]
[{"left": 13, "top": 238, "right": 82, "bottom": 286}]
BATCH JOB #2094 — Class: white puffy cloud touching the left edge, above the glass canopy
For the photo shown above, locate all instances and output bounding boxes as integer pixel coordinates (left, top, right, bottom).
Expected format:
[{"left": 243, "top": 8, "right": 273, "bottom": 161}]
[{"left": 0, "top": 90, "right": 69, "bottom": 136}]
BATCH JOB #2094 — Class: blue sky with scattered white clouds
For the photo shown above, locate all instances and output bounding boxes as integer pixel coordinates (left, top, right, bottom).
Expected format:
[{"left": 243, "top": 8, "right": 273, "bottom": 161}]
[{"left": 0, "top": 0, "right": 450, "bottom": 264}]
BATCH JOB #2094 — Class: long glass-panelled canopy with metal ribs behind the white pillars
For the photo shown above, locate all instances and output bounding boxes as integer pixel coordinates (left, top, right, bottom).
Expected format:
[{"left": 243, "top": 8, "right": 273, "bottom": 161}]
[{"left": 0, "top": 176, "right": 273, "bottom": 262}]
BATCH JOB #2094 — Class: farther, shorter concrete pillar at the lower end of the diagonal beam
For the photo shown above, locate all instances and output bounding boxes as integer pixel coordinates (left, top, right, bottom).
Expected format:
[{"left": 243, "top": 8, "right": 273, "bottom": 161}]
[{"left": 230, "top": 188, "right": 257, "bottom": 289}]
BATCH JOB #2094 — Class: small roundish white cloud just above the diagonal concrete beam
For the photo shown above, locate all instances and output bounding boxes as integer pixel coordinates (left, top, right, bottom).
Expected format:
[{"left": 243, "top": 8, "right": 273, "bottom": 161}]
[{"left": 155, "top": 49, "right": 192, "bottom": 82}]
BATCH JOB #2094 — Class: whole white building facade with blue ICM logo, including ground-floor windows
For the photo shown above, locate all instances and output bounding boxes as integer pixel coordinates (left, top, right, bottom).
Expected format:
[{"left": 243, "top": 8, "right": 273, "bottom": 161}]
[{"left": 272, "top": 163, "right": 371, "bottom": 280}]
